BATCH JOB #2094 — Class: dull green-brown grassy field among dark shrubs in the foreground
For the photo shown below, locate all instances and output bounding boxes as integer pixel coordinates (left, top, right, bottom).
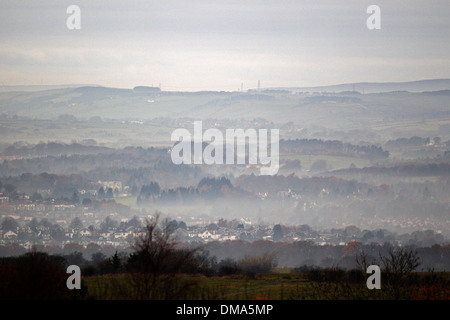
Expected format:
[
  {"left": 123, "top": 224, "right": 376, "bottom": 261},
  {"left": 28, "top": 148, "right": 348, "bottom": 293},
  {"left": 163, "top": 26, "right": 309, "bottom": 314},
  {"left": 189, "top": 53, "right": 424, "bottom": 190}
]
[{"left": 84, "top": 270, "right": 450, "bottom": 300}]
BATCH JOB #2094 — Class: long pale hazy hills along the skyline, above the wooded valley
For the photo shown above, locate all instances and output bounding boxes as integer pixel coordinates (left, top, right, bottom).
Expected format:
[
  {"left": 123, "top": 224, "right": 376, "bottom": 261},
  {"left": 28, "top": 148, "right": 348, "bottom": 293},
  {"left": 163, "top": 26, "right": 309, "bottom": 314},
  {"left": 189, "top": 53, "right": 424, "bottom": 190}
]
[{"left": 0, "top": 79, "right": 450, "bottom": 139}]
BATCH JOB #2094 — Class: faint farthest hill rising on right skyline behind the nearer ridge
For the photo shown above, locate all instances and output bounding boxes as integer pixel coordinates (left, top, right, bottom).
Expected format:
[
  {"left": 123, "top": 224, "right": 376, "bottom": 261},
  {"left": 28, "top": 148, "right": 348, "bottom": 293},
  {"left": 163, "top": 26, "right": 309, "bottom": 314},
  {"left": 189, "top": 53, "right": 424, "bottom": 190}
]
[{"left": 268, "top": 79, "right": 450, "bottom": 93}]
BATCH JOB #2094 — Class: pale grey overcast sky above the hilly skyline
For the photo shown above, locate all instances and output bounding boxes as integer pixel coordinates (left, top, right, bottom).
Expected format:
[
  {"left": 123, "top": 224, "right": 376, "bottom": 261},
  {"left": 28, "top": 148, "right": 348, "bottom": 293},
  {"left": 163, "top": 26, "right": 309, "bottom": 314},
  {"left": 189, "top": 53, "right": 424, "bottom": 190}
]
[{"left": 0, "top": 0, "right": 450, "bottom": 91}]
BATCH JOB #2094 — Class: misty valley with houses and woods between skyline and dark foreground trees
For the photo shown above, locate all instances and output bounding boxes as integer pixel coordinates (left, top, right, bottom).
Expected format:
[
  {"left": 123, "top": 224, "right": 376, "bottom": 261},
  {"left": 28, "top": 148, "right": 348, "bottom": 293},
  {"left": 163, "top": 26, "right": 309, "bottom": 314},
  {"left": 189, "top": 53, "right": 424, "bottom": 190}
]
[{"left": 0, "top": 84, "right": 450, "bottom": 270}]
